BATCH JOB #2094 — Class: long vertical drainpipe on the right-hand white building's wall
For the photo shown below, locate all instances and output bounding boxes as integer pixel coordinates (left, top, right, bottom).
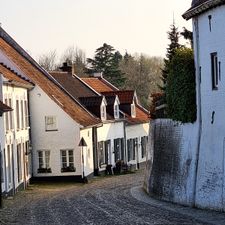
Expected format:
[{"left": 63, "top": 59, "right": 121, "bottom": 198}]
[{"left": 193, "top": 18, "right": 202, "bottom": 206}]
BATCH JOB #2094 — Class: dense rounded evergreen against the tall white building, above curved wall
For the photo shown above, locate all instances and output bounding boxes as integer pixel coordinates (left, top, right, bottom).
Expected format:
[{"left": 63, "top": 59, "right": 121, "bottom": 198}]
[{"left": 166, "top": 47, "right": 196, "bottom": 123}]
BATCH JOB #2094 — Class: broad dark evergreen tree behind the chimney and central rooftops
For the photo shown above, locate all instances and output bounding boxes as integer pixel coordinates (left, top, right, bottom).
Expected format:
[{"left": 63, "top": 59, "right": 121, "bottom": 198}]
[{"left": 87, "top": 43, "right": 125, "bottom": 88}]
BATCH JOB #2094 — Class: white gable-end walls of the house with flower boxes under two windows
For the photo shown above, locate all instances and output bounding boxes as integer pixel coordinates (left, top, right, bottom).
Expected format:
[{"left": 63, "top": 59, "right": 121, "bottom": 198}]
[{"left": 30, "top": 86, "right": 93, "bottom": 177}]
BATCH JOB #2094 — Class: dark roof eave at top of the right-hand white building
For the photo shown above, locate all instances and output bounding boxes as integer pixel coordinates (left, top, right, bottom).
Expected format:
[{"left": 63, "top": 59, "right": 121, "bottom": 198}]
[{"left": 182, "top": 0, "right": 225, "bottom": 20}]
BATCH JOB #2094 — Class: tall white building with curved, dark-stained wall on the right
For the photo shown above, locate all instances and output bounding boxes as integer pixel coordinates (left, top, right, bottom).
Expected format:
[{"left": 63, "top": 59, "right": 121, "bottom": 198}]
[{"left": 145, "top": 0, "right": 225, "bottom": 211}]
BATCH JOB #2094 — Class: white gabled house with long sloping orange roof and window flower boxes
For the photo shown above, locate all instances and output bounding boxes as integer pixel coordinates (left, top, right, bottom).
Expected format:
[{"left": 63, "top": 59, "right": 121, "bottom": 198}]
[{"left": 0, "top": 28, "right": 101, "bottom": 180}]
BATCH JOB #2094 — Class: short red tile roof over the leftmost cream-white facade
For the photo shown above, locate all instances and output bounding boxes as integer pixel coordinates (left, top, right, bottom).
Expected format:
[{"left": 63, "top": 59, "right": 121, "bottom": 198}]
[{"left": 0, "top": 62, "right": 33, "bottom": 86}]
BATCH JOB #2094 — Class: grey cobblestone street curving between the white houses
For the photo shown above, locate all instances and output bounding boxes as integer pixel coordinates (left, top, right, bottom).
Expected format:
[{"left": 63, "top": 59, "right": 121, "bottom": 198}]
[{"left": 0, "top": 171, "right": 225, "bottom": 225}]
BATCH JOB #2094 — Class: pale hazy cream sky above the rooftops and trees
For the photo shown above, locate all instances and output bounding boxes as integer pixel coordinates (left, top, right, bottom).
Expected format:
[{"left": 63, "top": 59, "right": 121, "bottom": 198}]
[{"left": 0, "top": 0, "right": 192, "bottom": 59}]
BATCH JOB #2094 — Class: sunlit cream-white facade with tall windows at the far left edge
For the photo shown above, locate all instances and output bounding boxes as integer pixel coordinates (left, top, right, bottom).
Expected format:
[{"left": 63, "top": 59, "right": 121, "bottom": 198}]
[{"left": 1, "top": 79, "right": 32, "bottom": 194}]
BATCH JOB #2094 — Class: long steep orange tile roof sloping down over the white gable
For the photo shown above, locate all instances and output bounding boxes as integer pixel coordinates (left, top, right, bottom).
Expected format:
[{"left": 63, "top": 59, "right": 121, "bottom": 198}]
[{"left": 0, "top": 34, "right": 101, "bottom": 126}]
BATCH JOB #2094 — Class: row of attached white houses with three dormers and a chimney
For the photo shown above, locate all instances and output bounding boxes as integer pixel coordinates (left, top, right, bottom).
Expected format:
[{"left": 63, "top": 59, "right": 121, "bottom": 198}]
[{"left": 50, "top": 67, "right": 149, "bottom": 175}]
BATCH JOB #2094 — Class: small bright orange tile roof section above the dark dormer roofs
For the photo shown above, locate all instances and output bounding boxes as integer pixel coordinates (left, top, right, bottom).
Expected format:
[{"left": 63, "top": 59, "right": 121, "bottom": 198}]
[{"left": 81, "top": 77, "right": 117, "bottom": 93}]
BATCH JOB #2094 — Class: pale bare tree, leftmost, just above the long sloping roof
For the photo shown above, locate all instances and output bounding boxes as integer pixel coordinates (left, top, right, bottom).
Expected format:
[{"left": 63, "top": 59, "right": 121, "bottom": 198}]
[{"left": 38, "top": 50, "right": 57, "bottom": 71}]
